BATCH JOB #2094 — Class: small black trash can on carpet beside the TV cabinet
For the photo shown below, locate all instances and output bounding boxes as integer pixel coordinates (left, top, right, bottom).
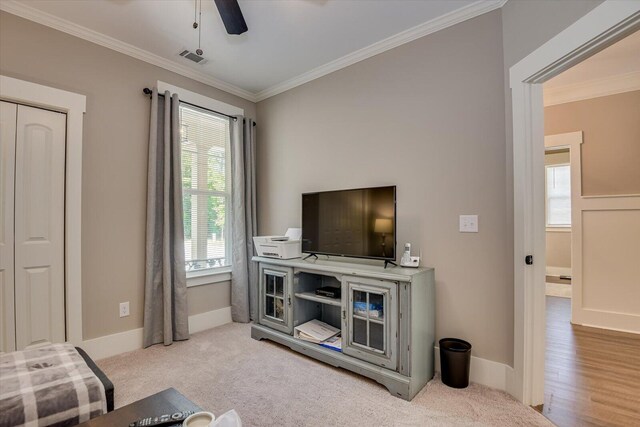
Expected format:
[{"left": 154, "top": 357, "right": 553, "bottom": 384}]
[{"left": 440, "top": 338, "right": 471, "bottom": 388}]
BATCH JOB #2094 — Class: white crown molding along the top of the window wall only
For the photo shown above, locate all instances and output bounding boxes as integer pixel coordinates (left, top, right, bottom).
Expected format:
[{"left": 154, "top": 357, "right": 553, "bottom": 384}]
[{"left": 0, "top": 0, "right": 256, "bottom": 102}]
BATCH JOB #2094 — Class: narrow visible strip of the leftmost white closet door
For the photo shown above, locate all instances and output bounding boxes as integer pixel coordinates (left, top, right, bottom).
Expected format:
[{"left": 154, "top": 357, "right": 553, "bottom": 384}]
[{"left": 0, "top": 102, "right": 18, "bottom": 352}]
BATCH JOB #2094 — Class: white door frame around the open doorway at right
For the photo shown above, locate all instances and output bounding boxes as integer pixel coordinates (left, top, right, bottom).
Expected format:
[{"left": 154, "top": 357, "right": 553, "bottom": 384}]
[{"left": 508, "top": 0, "right": 640, "bottom": 405}]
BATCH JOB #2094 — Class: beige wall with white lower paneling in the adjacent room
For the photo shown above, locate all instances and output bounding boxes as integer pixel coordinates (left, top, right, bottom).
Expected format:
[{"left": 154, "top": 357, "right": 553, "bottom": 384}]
[{"left": 545, "top": 90, "right": 640, "bottom": 333}]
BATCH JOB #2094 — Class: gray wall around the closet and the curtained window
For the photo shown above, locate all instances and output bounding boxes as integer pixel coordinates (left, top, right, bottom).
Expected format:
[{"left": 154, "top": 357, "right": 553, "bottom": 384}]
[{"left": 0, "top": 12, "right": 255, "bottom": 339}]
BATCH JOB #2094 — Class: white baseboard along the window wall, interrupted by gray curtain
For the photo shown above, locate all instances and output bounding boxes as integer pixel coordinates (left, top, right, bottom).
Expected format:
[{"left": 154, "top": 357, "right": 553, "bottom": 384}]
[{"left": 80, "top": 307, "right": 231, "bottom": 360}]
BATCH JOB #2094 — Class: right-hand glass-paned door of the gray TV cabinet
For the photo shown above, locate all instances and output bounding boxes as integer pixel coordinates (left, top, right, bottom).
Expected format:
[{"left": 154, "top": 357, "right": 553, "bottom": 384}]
[{"left": 344, "top": 278, "right": 397, "bottom": 369}]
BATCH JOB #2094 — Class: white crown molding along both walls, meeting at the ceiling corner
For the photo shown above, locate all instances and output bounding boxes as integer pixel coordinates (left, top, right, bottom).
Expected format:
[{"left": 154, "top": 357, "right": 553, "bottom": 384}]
[{"left": 0, "top": 0, "right": 508, "bottom": 102}]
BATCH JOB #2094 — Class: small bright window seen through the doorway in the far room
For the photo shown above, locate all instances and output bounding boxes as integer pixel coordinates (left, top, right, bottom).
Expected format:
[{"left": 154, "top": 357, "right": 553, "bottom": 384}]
[{"left": 546, "top": 165, "right": 571, "bottom": 227}]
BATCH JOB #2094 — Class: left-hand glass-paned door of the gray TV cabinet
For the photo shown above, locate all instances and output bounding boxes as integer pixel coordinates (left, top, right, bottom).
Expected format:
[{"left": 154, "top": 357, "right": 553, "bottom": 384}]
[{"left": 260, "top": 266, "right": 291, "bottom": 333}]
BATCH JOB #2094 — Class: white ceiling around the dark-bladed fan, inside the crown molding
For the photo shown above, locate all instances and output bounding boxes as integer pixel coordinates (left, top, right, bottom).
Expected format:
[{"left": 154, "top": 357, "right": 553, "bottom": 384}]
[{"left": 3, "top": 0, "right": 496, "bottom": 99}]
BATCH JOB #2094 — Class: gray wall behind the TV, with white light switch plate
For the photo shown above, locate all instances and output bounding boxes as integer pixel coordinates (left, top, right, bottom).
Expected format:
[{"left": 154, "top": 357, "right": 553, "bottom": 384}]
[{"left": 258, "top": 11, "right": 513, "bottom": 363}]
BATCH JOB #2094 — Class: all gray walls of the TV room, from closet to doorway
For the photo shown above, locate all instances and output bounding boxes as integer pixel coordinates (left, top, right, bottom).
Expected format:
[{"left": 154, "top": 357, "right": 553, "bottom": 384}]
[{"left": 0, "top": 0, "right": 599, "bottom": 364}]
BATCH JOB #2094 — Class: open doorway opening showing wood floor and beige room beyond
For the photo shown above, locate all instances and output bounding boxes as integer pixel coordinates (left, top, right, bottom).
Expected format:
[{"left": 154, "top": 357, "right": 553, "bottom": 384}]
[{"left": 542, "top": 32, "right": 640, "bottom": 426}]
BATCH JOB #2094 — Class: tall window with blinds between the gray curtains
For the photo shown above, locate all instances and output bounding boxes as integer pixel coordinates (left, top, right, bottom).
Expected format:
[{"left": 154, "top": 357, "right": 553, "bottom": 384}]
[{"left": 180, "top": 103, "right": 231, "bottom": 272}]
